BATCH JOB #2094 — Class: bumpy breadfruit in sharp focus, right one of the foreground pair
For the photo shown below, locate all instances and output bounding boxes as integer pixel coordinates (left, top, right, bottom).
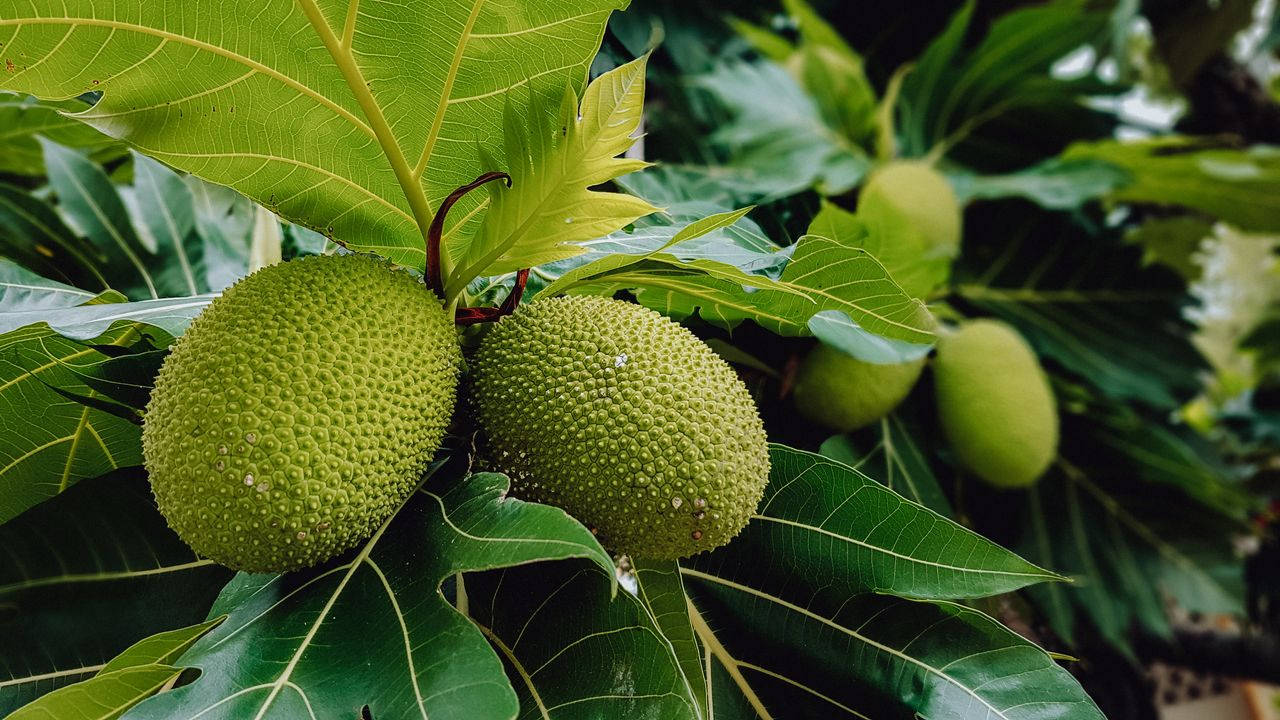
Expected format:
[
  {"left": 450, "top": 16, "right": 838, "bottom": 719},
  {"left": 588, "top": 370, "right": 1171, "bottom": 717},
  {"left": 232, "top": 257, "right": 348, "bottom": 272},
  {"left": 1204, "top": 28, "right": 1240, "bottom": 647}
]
[{"left": 474, "top": 297, "right": 769, "bottom": 560}]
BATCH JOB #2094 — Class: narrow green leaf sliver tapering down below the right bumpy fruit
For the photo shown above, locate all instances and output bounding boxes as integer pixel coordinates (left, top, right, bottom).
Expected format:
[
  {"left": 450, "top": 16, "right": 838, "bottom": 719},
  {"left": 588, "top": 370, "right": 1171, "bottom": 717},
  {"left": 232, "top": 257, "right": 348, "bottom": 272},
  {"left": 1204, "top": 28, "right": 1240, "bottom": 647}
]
[{"left": 631, "top": 559, "right": 710, "bottom": 717}]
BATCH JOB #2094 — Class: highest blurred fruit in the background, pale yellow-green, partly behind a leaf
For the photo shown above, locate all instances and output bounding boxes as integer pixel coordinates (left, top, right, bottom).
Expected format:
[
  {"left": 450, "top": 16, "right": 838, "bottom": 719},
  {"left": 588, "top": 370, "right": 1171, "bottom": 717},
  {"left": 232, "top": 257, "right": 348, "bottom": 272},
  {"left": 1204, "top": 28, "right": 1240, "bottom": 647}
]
[{"left": 858, "top": 160, "right": 963, "bottom": 258}]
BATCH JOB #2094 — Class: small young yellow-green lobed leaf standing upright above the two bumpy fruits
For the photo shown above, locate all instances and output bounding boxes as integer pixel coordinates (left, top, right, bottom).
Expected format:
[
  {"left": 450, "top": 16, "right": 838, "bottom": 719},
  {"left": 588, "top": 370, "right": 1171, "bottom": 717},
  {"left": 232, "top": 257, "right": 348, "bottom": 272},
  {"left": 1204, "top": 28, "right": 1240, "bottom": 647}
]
[{"left": 445, "top": 56, "right": 657, "bottom": 297}]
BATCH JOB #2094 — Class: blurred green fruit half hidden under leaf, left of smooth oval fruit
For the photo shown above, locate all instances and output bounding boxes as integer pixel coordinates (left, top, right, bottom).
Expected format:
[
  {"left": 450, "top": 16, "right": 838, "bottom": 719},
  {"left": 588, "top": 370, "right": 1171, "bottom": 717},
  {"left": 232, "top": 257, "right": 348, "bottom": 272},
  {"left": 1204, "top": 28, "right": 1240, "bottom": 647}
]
[{"left": 795, "top": 345, "right": 924, "bottom": 432}]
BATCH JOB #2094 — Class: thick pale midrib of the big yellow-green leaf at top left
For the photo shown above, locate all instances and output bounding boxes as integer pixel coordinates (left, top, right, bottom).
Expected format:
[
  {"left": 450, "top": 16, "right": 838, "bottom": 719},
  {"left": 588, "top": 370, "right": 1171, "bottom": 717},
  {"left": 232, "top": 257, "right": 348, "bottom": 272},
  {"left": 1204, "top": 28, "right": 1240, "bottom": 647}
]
[{"left": 295, "top": 0, "right": 440, "bottom": 274}]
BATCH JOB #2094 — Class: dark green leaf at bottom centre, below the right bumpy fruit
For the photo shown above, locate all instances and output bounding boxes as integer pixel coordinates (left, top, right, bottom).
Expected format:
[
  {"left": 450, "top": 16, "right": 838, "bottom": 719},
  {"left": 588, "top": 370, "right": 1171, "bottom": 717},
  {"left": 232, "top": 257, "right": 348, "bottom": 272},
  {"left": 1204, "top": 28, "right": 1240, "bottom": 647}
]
[{"left": 465, "top": 562, "right": 701, "bottom": 720}]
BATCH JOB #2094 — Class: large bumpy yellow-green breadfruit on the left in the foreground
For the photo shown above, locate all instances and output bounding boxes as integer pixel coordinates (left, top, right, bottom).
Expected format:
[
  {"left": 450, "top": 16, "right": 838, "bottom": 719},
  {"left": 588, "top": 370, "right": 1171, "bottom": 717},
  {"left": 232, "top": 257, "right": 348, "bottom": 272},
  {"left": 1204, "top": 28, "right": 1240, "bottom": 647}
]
[{"left": 142, "top": 255, "right": 462, "bottom": 573}]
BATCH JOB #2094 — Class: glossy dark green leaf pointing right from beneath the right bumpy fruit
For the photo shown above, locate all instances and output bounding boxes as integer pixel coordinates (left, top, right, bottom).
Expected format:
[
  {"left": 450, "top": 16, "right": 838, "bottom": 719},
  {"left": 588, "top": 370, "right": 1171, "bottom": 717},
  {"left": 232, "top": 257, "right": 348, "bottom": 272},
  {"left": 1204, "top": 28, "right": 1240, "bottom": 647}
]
[{"left": 682, "top": 445, "right": 1061, "bottom": 598}]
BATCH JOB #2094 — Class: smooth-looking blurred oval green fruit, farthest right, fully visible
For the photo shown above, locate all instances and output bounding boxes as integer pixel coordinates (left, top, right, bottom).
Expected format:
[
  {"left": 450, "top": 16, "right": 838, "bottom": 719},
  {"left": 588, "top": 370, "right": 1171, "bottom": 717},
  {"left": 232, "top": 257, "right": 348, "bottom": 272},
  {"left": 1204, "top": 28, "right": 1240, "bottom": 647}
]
[{"left": 933, "top": 320, "right": 1057, "bottom": 488}]
